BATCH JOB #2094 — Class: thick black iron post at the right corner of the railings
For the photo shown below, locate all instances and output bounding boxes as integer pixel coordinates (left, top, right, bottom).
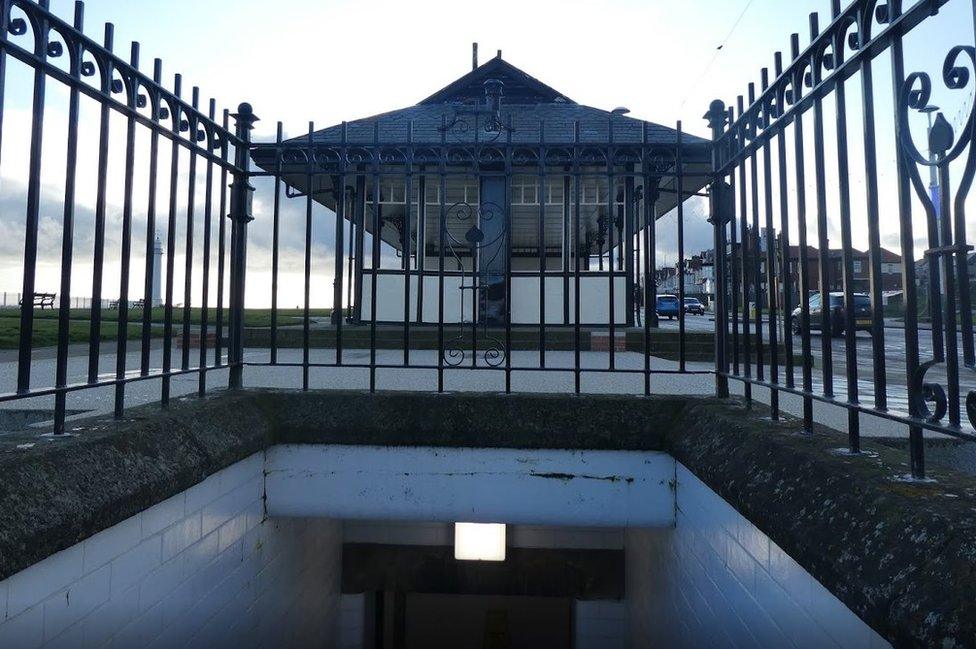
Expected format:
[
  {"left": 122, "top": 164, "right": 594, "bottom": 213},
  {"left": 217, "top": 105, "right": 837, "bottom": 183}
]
[{"left": 705, "top": 99, "right": 729, "bottom": 399}]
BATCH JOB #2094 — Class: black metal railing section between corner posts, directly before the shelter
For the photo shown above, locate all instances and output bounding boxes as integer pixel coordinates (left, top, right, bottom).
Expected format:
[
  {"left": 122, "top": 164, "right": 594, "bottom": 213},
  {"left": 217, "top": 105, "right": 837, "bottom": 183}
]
[{"left": 244, "top": 114, "right": 713, "bottom": 394}]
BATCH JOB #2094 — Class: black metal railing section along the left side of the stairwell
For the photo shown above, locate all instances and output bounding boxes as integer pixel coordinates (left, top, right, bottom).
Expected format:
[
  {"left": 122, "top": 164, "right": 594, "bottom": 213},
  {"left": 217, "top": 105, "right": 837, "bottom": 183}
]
[{"left": 0, "top": 0, "right": 247, "bottom": 433}]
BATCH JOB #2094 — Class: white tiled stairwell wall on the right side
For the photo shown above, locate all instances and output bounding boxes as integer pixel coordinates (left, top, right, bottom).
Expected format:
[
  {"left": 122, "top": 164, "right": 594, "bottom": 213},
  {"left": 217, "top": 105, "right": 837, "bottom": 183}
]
[{"left": 625, "top": 464, "right": 889, "bottom": 649}]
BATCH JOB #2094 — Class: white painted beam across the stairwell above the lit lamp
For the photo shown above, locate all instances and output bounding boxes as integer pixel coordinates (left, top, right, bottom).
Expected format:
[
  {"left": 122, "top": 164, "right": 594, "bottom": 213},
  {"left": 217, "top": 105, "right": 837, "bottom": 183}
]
[{"left": 266, "top": 445, "right": 675, "bottom": 527}]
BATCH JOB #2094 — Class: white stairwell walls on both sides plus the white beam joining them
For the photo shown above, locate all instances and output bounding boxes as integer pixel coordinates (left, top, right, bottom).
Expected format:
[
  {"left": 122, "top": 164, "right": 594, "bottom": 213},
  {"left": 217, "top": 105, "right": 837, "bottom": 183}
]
[{"left": 0, "top": 446, "right": 888, "bottom": 649}]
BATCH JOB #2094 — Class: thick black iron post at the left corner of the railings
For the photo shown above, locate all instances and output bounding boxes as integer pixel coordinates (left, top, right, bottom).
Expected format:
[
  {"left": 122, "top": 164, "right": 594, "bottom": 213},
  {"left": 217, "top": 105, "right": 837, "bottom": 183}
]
[{"left": 227, "top": 103, "right": 258, "bottom": 389}]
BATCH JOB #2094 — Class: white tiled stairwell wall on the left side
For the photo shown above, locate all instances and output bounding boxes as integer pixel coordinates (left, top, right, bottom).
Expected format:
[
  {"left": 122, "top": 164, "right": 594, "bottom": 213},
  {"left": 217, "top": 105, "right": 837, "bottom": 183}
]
[{"left": 0, "top": 453, "right": 341, "bottom": 649}]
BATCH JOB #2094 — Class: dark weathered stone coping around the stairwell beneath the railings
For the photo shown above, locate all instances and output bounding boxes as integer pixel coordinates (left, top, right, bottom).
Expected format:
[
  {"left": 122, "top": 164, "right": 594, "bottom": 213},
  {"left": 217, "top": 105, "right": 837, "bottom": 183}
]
[{"left": 0, "top": 390, "right": 976, "bottom": 646}]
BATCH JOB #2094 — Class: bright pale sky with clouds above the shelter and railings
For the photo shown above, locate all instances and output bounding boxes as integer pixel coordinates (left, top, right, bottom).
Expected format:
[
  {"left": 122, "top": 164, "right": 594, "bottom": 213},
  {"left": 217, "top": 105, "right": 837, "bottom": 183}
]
[{"left": 0, "top": 0, "right": 973, "bottom": 306}]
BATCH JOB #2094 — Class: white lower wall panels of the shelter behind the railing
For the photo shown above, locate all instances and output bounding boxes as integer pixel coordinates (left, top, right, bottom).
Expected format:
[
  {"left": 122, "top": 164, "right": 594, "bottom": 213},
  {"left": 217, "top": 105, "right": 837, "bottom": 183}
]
[{"left": 361, "top": 270, "right": 627, "bottom": 325}]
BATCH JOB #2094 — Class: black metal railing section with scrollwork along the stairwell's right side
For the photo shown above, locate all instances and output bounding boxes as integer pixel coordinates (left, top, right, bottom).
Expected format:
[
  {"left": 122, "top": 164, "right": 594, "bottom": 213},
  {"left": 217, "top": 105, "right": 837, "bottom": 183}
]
[{"left": 707, "top": 0, "right": 976, "bottom": 478}]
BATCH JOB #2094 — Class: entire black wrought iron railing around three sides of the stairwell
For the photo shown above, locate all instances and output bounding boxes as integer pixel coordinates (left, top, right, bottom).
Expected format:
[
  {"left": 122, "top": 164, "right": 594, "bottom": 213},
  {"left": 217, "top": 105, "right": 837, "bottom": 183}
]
[{"left": 0, "top": 0, "right": 976, "bottom": 486}]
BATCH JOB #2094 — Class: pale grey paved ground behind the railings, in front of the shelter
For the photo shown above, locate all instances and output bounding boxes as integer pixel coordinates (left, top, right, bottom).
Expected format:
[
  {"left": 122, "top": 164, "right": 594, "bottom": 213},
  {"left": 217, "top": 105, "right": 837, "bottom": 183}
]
[{"left": 0, "top": 347, "right": 932, "bottom": 436}]
